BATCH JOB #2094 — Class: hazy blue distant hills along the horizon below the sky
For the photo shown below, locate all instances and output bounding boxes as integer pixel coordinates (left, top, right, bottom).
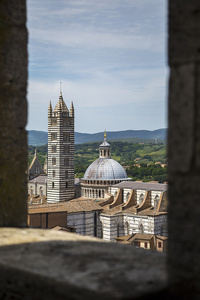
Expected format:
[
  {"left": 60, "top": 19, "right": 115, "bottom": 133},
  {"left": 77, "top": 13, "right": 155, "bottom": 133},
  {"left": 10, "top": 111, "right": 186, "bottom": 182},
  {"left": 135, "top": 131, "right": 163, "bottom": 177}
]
[{"left": 28, "top": 128, "right": 167, "bottom": 146}]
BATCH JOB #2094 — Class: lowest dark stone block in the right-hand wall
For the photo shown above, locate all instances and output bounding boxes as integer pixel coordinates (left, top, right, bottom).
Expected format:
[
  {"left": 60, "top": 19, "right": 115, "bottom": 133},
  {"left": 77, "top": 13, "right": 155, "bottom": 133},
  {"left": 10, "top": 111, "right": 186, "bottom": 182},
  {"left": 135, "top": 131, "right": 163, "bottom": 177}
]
[{"left": 168, "top": 173, "right": 200, "bottom": 290}]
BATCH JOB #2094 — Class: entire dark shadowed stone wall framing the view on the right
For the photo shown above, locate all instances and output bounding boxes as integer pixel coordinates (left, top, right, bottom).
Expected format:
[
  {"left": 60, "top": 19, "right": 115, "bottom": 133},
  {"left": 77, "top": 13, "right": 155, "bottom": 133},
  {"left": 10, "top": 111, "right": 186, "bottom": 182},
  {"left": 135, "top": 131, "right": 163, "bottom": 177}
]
[{"left": 168, "top": 0, "right": 200, "bottom": 299}]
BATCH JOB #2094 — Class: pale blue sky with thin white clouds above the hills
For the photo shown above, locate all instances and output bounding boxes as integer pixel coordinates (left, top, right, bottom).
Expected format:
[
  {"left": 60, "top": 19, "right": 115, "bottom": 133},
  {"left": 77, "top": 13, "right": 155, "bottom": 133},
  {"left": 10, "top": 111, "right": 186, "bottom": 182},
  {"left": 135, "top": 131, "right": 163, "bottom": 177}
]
[{"left": 27, "top": 0, "right": 168, "bottom": 133}]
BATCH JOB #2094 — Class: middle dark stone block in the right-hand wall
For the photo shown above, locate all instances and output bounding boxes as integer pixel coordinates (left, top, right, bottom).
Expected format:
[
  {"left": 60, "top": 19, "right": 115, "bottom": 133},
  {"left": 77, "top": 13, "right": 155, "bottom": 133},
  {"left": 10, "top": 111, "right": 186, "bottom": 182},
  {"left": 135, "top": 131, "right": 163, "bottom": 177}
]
[{"left": 168, "top": 64, "right": 195, "bottom": 173}]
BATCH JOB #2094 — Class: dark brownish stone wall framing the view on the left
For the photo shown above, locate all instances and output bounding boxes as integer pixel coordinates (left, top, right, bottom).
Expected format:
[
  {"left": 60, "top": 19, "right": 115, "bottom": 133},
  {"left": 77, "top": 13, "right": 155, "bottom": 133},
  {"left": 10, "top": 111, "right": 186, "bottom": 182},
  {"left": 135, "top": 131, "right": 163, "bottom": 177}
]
[{"left": 0, "top": 0, "right": 28, "bottom": 226}]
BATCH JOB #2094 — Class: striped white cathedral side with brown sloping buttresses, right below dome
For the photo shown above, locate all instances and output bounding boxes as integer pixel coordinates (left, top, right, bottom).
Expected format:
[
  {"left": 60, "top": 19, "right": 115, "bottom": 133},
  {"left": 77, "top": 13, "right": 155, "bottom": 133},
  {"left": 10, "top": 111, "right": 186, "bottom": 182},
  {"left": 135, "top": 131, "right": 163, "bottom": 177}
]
[{"left": 100, "top": 181, "right": 168, "bottom": 241}]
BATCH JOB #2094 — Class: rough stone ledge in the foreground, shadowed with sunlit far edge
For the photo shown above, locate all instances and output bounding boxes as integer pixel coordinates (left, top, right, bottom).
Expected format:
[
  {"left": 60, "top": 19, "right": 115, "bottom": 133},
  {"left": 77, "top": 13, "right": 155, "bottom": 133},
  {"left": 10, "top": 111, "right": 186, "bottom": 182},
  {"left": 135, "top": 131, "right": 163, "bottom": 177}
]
[{"left": 0, "top": 229, "right": 167, "bottom": 300}]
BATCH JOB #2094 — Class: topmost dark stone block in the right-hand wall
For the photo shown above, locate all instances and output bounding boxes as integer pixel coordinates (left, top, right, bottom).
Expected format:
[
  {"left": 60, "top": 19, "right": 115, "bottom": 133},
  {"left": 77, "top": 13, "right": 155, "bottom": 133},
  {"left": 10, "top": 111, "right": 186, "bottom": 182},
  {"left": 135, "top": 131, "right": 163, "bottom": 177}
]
[{"left": 168, "top": 0, "right": 200, "bottom": 66}]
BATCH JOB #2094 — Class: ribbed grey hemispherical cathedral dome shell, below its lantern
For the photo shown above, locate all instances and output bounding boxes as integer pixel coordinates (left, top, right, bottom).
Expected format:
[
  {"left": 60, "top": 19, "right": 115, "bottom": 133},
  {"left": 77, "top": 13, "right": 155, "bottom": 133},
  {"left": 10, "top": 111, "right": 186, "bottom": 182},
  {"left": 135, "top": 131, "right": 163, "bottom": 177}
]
[{"left": 83, "top": 158, "right": 127, "bottom": 180}]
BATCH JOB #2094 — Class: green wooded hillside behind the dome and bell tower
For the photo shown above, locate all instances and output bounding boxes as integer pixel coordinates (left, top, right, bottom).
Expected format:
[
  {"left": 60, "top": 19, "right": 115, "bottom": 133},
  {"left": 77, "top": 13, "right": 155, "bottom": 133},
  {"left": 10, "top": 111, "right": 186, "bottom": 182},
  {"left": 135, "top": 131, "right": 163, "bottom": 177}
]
[{"left": 29, "top": 142, "right": 167, "bottom": 182}]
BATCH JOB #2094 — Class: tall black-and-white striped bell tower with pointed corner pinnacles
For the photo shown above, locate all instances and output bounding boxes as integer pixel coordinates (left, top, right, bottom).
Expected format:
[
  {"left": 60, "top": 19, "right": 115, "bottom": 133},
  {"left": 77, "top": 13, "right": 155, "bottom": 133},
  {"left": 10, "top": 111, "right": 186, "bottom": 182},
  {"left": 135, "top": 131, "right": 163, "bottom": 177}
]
[{"left": 47, "top": 92, "right": 75, "bottom": 203}]
